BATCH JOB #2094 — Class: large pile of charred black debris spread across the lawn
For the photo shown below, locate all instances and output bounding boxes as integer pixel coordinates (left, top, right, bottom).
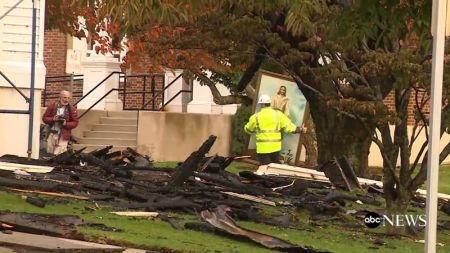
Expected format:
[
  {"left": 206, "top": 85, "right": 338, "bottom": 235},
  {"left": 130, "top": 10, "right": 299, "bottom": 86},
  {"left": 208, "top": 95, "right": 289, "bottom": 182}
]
[{"left": 0, "top": 136, "right": 446, "bottom": 252}]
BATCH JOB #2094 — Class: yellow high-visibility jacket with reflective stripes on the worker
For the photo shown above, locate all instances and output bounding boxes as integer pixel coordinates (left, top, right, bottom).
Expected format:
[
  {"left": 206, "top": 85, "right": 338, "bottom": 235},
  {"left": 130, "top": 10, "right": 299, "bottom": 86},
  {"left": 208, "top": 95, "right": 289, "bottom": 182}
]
[{"left": 244, "top": 107, "right": 297, "bottom": 154}]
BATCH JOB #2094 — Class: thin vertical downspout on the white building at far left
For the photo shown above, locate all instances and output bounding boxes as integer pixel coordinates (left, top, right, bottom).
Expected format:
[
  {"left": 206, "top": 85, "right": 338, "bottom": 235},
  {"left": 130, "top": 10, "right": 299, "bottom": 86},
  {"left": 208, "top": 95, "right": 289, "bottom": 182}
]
[{"left": 27, "top": 0, "right": 36, "bottom": 159}]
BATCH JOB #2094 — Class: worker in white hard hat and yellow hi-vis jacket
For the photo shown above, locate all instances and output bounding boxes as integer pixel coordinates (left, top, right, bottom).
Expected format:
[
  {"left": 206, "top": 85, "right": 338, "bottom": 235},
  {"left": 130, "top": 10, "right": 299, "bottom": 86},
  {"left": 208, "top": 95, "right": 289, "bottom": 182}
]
[{"left": 244, "top": 95, "right": 306, "bottom": 165}]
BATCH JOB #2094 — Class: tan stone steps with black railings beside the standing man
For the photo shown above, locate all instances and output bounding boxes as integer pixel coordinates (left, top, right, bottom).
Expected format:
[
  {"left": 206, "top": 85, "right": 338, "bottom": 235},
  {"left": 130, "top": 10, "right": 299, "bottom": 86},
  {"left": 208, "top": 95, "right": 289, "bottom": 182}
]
[{"left": 73, "top": 111, "right": 137, "bottom": 152}]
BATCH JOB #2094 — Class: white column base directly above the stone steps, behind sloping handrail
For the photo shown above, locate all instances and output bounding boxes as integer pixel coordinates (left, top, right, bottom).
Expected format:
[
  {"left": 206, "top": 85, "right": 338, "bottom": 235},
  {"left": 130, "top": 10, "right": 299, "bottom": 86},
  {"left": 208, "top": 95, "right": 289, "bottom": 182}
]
[{"left": 78, "top": 55, "right": 123, "bottom": 111}]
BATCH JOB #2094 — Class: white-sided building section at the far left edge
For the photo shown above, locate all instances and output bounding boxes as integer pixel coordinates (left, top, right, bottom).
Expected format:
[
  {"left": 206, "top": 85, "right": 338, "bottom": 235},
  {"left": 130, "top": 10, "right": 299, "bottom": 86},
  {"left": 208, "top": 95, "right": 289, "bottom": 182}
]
[{"left": 0, "top": 0, "right": 46, "bottom": 158}]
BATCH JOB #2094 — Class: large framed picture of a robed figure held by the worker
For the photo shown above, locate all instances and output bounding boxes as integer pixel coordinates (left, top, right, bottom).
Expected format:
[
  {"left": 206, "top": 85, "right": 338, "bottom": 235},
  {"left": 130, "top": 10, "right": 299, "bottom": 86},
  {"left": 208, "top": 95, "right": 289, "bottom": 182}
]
[{"left": 248, "top": 71, "right": 307, "bottom": 165}]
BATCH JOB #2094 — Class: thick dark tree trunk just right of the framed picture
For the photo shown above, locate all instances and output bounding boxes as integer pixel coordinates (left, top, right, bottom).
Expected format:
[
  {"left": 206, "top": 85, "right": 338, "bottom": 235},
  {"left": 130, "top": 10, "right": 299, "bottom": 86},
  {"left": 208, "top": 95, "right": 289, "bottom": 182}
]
[{"left": 308, "top": 99, "right": 372, "bottom": 177}]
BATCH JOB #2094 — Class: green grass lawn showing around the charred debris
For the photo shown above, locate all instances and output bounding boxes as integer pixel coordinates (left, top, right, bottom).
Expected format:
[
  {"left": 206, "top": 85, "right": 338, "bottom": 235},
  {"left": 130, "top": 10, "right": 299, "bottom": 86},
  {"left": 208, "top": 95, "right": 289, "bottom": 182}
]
[{"left": 0, "top": 162, "right": 450, "bottom": 253}]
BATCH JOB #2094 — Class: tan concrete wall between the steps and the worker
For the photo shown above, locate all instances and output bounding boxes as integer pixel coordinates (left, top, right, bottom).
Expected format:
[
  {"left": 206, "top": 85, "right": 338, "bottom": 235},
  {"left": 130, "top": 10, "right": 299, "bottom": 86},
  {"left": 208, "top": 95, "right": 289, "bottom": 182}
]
[{"left": 137, "top": 112, "right": 234, "bottom": 161}]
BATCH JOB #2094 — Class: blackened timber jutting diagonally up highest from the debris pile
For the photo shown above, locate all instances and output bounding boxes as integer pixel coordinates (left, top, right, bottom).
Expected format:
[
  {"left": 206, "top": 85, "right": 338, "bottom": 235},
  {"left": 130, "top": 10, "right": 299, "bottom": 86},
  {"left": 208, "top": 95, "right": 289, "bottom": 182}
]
[{"left": 168, "top": 135, "right": 217, "bottom": 189}]
